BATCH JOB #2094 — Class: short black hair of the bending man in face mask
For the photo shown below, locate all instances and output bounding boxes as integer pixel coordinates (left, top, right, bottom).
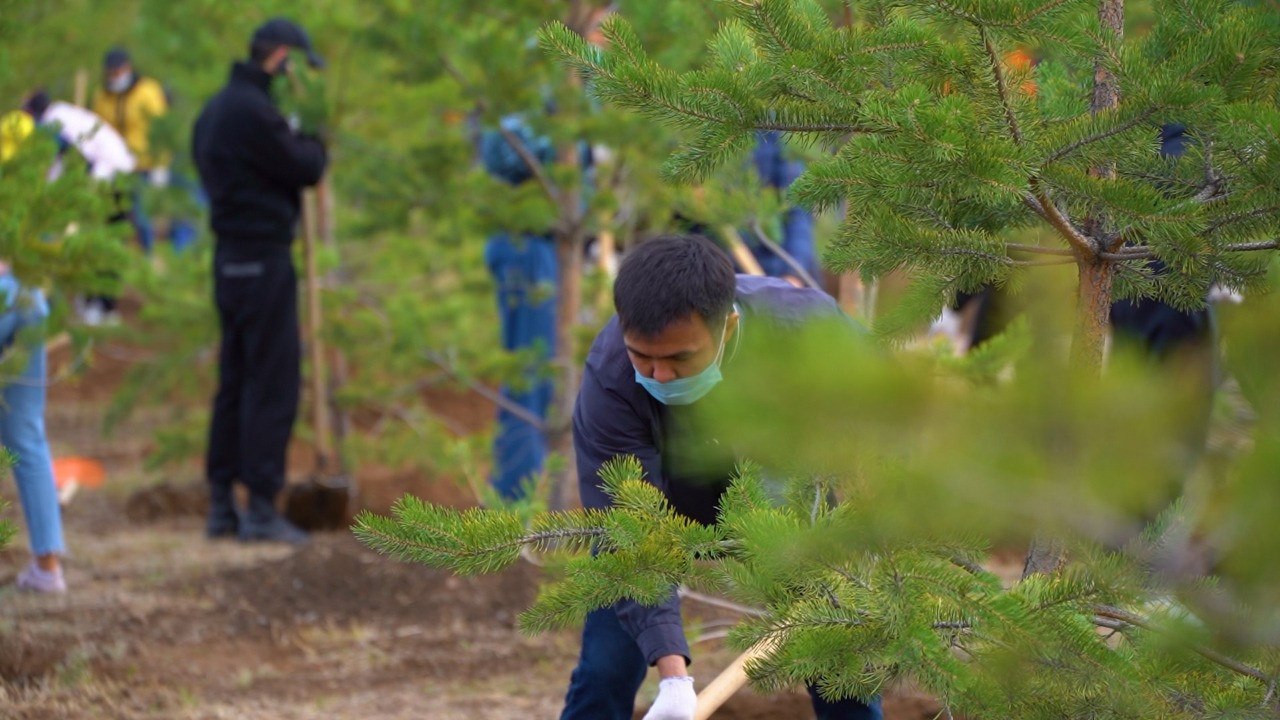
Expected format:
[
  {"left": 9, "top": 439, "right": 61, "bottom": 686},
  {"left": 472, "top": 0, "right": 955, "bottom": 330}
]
[{"left": 613, "top": 234, "right": 736, "bottom": 337}]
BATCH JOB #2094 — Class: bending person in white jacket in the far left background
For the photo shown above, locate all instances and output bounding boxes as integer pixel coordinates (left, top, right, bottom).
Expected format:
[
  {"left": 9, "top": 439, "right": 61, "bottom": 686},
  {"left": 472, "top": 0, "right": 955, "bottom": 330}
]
[{"left": 23, "top": 90, "right": 137, "bottom": 181}]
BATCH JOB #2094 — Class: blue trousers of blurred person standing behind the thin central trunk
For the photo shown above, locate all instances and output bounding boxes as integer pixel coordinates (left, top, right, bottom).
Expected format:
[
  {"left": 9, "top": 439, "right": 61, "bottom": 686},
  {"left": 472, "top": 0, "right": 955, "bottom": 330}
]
[{"left": 485, "top": 233, "right": 558, "bottom": 500}]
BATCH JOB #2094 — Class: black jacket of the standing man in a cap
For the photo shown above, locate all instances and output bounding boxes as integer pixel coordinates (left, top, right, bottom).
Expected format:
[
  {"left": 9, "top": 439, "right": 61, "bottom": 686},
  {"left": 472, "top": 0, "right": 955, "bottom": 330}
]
[{"left": 191, "top": 63, "right": 326, "bottom": 245}]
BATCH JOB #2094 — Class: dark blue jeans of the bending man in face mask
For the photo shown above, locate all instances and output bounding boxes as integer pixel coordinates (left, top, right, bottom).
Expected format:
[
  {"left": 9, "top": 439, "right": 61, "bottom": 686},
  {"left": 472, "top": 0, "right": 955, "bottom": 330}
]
[{"left": 561, "top": 607, "right": 884, "bottom": 720}]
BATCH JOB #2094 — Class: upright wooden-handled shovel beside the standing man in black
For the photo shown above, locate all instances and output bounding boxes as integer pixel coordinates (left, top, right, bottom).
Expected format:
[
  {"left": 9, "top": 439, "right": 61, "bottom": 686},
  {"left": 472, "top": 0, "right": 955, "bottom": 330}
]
[{"left": 284, "top": 179, "right": 356, "bottom": 532}]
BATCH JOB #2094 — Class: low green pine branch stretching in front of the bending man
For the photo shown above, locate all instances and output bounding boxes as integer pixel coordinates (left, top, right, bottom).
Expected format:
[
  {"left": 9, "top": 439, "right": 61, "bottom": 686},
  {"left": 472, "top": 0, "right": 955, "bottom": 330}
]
[{"left": 356, "top": 459, "right": 1271, "bottom": 717}]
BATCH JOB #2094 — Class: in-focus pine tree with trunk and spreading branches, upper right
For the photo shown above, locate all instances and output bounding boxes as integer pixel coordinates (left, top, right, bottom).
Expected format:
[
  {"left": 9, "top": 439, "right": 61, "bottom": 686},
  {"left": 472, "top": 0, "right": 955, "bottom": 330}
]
[{"left": 545, "top": 0, "right": 1280, "bottom": 571}]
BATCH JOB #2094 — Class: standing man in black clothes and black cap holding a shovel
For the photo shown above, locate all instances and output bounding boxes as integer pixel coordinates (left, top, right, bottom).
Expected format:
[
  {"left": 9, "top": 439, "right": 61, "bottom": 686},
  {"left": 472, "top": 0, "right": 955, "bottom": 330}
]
[{"left": 192, "top": 18, "right": 326, "bottom": 543}]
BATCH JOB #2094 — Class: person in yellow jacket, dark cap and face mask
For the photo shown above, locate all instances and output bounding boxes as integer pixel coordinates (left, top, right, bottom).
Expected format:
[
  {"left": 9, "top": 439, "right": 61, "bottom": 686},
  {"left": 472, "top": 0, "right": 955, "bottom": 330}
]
[{"left": 92, "top": 47, "right": 200, "bottom": 254}]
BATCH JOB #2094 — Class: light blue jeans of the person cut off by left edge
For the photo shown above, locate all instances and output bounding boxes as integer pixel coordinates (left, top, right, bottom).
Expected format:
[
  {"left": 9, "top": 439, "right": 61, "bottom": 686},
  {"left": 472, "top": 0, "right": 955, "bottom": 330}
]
[{"left": 0, "top": 345, "right": 65, "bottom": 555}]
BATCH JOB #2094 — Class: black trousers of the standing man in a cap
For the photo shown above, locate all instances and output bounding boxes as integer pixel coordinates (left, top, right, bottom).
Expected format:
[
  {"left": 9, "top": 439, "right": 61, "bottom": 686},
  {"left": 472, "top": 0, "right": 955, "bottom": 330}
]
[{"left": 206, "top": 240, "right": 302, "bottom": 498}]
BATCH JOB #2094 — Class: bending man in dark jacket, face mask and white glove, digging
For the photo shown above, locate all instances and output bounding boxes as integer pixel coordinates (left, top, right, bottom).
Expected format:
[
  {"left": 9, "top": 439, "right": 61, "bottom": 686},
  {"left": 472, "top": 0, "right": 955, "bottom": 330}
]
[{"left": 561, "top": 236, "right": 882, "bottom": 720}]
